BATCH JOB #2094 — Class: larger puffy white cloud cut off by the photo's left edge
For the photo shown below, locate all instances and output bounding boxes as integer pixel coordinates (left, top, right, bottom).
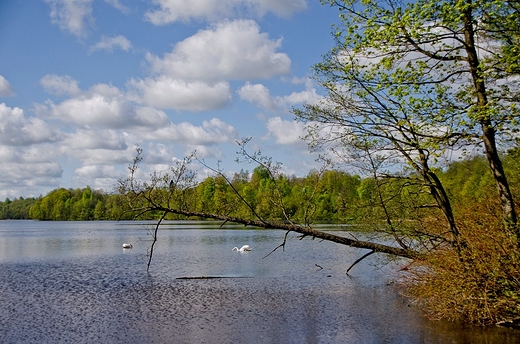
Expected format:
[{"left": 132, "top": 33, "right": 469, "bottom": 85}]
[{"left": 0, "top": 103, "right": 61, "bottom": 146}]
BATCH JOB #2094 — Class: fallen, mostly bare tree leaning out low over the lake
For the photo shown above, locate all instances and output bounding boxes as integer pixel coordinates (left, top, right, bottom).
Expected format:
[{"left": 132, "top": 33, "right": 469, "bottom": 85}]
[{"left": 118, "top": 141, "right": 421, "bottom": 276}]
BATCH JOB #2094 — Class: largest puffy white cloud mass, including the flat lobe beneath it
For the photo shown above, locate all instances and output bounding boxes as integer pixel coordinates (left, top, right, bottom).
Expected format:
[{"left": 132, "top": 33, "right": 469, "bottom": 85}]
[{"left": 127, "top": 20, "right": 291, "bottom": 111}]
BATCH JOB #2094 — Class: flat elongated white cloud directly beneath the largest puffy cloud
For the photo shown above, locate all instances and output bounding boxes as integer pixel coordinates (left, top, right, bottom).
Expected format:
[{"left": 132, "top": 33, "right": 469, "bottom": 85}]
[{"left": 128, "top": 76, "right": 232, "bottom": 111}]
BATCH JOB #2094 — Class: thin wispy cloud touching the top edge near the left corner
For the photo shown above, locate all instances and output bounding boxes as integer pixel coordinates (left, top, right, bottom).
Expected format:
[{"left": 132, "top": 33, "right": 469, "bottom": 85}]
[{"left": 45, "top": 0, "right": 94, "bottom": 37}]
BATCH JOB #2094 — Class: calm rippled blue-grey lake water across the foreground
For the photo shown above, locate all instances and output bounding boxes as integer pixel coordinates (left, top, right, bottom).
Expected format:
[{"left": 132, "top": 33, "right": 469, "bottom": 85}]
[{"left": 0, "top": 221, "right": 520, "bottom": 343}]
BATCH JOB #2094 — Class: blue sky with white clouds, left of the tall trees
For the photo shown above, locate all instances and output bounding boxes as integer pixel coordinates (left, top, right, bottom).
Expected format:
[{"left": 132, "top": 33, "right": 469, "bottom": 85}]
[{"left": 0, "top": 0, "right": 338, "bottom": 200}]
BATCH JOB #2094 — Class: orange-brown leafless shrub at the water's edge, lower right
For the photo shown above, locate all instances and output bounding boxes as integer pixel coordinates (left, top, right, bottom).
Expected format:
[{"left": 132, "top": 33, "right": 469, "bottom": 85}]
[{"left": 406, "top": 205, "right": 520, "bottom": 325}]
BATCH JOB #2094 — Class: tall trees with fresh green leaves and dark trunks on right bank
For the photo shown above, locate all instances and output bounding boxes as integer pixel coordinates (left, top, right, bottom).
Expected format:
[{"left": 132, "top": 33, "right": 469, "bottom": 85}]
[{"left": 295, "top": 0, "right": 520, "bottom": 240}]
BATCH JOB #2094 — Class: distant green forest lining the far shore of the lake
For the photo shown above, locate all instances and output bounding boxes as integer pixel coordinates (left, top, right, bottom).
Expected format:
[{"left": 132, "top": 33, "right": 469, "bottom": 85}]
[{"left": 0, "top": 149, "right": 520, "bottom": 222}]
